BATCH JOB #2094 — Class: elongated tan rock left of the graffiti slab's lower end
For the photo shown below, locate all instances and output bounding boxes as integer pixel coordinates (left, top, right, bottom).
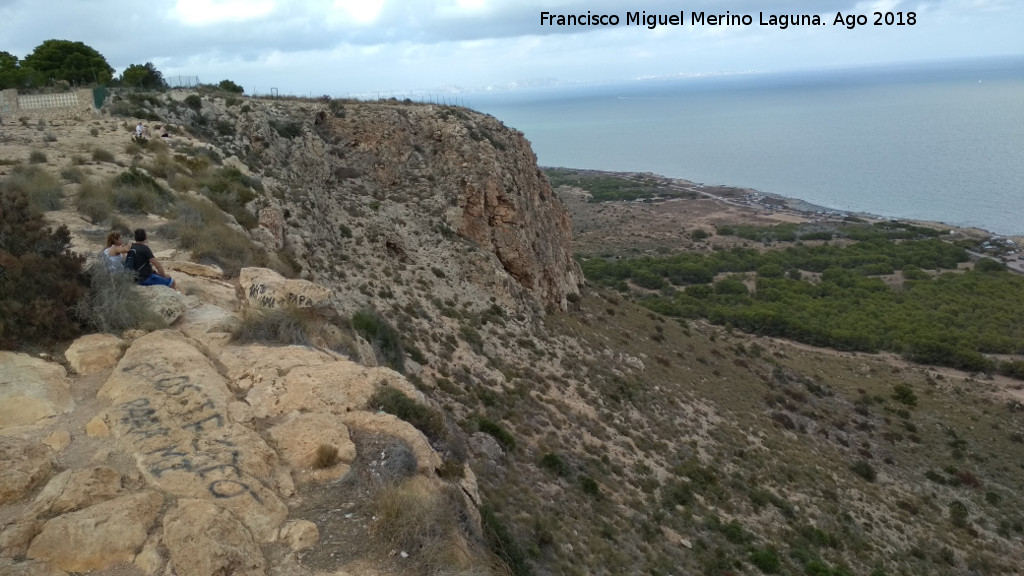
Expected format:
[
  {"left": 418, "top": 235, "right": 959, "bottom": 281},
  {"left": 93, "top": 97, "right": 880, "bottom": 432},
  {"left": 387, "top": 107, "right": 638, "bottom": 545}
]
[{"left": 29, "top": 466, "right": 123, "bottom": 517}]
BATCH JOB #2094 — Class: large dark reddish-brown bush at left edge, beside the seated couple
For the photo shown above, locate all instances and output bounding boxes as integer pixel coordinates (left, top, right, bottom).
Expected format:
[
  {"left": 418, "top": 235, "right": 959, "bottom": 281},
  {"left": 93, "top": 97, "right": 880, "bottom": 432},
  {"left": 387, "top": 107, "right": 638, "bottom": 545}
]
[{"left": 0, "top": 186, "right": 87, "bottom": 349}]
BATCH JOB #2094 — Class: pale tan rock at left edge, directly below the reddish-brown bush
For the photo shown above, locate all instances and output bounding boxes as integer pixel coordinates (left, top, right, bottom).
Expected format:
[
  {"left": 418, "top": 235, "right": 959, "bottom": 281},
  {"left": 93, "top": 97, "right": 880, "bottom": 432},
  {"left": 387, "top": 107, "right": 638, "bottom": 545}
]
[{"left": 0, "top": 352, "right": 75, "bottom": 428}]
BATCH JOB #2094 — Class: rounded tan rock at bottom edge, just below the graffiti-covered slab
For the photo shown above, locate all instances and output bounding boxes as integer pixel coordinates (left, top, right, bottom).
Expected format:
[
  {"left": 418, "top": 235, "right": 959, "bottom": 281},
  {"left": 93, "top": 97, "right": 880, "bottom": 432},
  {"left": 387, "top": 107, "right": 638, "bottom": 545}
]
[{"left": 163, "top": 499, "right": 265, "bottom": 576}]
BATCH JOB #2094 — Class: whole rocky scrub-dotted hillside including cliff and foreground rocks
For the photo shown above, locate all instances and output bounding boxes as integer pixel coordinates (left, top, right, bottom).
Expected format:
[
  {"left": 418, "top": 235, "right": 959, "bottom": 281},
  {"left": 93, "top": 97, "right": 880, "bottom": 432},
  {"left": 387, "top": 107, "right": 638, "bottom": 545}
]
[{"left": 0, "top": 92, "right": 1024, "bottom": 575}]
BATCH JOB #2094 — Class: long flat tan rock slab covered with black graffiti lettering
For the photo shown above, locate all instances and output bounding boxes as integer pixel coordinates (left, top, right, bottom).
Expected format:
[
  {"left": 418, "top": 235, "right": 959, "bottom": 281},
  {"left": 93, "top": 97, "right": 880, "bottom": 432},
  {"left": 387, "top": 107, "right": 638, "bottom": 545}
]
[{"left": 98, "top": 330, "right": 288, "bottom": 542}]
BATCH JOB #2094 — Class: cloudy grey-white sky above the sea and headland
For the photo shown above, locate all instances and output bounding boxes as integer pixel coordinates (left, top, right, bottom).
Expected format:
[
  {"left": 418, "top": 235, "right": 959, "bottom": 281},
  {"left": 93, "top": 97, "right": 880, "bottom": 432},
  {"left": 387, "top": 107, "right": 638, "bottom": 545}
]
[{"left": 0, "top": 0, "right": 1024, "bottom": 96}]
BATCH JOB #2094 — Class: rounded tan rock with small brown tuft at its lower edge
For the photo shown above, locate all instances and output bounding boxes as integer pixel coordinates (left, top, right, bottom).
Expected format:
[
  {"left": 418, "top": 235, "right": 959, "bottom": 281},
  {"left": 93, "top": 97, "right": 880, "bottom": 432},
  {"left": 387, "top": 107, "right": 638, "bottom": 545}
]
[{"left": 270, "top": 413, "right": 355, "bottom": 469}]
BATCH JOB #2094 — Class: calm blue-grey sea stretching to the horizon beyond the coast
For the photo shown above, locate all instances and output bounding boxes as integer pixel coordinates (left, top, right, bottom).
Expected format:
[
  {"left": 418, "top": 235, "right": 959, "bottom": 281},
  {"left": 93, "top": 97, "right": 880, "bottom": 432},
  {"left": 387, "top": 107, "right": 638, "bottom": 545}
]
[{"left": 467, "top": 55, "right": 1024, "bottom": 236}]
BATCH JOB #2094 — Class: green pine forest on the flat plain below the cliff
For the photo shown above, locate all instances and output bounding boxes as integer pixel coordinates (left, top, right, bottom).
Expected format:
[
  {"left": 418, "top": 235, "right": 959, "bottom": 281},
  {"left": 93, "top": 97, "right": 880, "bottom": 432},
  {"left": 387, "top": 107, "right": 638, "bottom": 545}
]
[{"left": 580, "top": 228, "right": 1024, "bottom": 379}]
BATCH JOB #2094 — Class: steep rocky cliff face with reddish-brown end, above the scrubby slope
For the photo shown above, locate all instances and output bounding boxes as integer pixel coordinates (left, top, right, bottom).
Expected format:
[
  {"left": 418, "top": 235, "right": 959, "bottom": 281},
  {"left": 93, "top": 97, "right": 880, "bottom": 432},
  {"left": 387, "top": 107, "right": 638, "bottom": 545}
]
[{"left": 236, "top": 101, "right": 583, "bottom": 310}]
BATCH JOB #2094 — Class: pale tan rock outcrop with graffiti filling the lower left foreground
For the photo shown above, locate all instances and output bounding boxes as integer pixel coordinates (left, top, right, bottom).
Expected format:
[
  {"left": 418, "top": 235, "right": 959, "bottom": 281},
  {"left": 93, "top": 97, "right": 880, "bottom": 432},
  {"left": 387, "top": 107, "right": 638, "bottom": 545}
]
[{"left": 0, "top": 266, "right": 479, "bottom": 576}]
